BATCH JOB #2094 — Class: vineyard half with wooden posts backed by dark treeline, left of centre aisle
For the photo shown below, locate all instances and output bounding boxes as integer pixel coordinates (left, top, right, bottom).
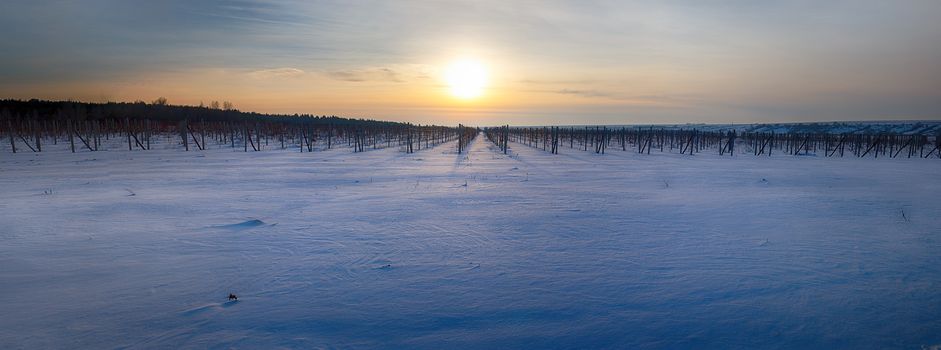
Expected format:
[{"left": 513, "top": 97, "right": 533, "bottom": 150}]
[{"left": 0, "top": 101, "right": 478, "bottom": 153}]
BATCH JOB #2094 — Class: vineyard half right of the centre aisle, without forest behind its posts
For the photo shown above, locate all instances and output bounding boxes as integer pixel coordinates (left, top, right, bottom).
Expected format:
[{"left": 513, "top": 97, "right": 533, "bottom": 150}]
[{"left": 484, "top": 126, "right": 941, "bottom": 158}]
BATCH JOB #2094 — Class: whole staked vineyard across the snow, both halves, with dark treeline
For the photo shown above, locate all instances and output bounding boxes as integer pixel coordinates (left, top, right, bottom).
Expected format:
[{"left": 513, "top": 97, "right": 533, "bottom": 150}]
[{"left": 0, "top": 100, "right": 941, "bottom": 158}]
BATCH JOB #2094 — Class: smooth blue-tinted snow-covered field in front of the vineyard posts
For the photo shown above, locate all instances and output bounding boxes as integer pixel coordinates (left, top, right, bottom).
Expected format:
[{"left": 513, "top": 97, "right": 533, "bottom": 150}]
[{"left": 0, "top": 136, "right": 941, "bottom": 349}]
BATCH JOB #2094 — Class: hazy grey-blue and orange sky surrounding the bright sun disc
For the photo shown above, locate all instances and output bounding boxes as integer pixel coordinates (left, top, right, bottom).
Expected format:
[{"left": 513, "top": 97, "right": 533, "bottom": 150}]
[{"left": 0, "top": 0, "right": 941, "bottom": 125}]
